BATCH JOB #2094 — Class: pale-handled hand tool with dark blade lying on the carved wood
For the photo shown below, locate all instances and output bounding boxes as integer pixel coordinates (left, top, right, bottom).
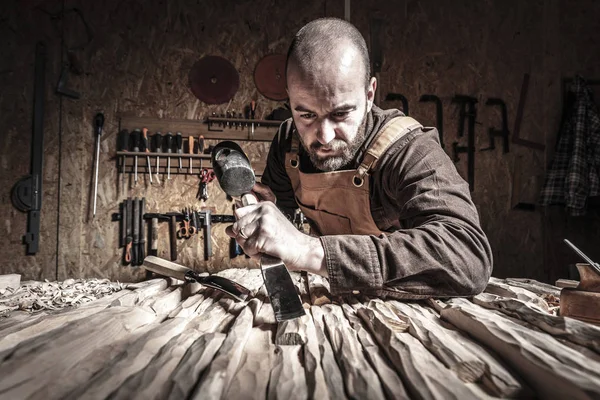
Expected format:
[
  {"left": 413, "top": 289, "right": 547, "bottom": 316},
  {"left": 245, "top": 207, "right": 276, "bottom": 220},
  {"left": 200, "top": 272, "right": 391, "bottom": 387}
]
[{"left": 144, "top": 257, "right": 252, "bottom": 301}]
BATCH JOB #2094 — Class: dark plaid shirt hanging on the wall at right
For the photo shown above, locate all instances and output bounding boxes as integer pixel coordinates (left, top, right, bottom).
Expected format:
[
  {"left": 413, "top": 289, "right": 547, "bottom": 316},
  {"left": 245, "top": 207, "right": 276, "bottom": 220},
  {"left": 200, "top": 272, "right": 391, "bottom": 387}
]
[{"left": 540, "top": 76, "right": 600, "bottom": 216}]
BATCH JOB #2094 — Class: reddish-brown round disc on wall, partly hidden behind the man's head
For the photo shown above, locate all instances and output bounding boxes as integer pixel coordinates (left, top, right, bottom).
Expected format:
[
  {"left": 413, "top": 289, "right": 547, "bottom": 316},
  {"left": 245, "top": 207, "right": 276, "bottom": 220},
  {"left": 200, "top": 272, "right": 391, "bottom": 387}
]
[{"left": 254, "top": 54, "right": 288, "bottom": 101}]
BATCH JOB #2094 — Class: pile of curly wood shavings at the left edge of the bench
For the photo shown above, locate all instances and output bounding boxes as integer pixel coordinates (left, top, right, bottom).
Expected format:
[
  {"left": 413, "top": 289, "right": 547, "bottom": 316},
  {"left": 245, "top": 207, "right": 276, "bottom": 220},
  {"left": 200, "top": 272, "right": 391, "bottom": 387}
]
[{"left": 0, "top": 279, "right": 125, "bottom": 317}]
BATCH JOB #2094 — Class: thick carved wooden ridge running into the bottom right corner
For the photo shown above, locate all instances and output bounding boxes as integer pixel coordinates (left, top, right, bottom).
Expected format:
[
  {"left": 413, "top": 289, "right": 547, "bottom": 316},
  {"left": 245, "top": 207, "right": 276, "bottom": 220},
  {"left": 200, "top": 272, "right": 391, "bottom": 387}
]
[{"left": 441, "top": 299, "right": 600, "bottom": 399}]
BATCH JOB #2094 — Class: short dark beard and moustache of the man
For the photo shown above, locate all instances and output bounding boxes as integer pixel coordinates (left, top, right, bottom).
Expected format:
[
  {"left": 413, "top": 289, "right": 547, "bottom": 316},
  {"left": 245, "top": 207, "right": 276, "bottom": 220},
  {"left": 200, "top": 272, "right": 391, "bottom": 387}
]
[{"left": 298, "top": 107, "right": 367, "bottom": 172}]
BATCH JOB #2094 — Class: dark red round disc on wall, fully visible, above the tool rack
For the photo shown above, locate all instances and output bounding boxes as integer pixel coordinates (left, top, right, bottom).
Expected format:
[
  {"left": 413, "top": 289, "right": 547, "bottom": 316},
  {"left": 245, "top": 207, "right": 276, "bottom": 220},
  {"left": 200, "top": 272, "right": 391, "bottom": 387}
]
[{"left": 189, "top": 56, "right": 240, "bottom": 104}]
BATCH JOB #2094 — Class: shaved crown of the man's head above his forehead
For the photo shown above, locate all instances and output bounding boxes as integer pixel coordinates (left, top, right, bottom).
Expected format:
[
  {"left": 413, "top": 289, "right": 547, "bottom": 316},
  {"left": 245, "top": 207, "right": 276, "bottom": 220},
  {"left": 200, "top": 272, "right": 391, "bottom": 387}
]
[{"left": 286, "top": 18, "right": 371, "bottom": 88}]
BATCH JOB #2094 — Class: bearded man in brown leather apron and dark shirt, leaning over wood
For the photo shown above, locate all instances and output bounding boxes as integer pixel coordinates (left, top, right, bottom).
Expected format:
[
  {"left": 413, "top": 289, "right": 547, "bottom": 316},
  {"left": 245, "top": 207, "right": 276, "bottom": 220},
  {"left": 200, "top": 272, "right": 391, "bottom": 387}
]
[{"left": 227, "top": 18, "right": 492, "bottom": 298}]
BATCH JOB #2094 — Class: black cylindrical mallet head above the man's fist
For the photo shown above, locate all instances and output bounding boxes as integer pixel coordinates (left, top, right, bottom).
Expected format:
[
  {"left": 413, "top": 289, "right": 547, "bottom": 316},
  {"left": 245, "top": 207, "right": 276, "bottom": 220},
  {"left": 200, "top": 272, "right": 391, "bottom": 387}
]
[{"left": 211, "top": 141, "right": 256, "bottom": 197}]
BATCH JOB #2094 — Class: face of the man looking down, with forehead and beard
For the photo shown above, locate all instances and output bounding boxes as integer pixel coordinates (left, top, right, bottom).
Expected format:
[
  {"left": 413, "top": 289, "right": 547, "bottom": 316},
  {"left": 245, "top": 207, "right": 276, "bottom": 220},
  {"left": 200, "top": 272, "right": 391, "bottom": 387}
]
[{"left": 287, "top": 51, "right": 376, "bottom": 171}]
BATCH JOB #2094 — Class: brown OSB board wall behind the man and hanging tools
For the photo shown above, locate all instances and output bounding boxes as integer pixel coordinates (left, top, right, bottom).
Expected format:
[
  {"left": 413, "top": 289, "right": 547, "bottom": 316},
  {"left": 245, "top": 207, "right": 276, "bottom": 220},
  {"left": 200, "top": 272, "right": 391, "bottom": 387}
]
[{"left": 0, "top": 0, "right": 585, "bottom": 280}]
